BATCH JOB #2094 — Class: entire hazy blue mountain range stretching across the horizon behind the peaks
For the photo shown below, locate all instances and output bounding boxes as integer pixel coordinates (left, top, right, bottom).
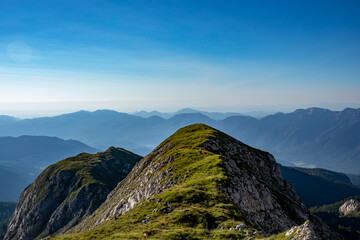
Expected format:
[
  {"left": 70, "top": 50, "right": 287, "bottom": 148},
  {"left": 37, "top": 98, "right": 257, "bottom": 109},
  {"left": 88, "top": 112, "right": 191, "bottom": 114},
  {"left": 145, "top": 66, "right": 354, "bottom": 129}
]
[{"left": 0, "top": 108, "right": 360, "bottom": 174}]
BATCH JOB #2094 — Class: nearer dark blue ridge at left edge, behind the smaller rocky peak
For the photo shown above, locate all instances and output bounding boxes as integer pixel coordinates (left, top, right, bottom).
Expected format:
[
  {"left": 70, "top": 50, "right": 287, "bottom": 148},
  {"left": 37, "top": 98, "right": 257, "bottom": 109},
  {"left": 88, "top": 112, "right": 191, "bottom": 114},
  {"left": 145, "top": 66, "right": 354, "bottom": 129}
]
[{"left": 0, "top": 136, "right": 98, "bottom": 201}]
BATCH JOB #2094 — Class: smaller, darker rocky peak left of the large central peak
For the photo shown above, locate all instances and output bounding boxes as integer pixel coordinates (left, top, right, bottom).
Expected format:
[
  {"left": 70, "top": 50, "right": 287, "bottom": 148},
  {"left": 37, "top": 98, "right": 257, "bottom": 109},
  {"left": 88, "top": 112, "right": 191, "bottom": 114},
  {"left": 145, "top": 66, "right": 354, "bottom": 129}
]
[{"left": 4, "top": 147, "right": 142, "bottom": 240}]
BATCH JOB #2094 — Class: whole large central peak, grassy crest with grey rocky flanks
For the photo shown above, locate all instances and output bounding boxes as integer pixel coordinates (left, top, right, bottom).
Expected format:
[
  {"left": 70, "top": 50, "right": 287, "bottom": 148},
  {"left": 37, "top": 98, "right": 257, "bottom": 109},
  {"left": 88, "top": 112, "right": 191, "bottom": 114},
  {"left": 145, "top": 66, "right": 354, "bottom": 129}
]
[{"left": 49, "top": 124, "right": 340, "bottom": 239}]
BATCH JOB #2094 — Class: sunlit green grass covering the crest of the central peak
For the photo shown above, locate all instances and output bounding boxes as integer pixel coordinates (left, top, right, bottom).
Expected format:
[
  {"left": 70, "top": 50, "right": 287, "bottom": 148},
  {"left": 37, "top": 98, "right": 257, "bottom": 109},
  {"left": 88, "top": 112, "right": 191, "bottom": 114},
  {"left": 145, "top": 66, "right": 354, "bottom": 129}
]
[{"left": 55, "top": 124, "right": 262, "bottom": 239}]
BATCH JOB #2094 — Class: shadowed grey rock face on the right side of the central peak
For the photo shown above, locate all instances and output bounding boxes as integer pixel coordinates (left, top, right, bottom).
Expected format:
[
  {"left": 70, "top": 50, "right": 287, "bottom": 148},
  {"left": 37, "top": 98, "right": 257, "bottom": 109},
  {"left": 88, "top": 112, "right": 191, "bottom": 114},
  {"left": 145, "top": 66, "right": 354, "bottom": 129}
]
[{"left": 204, "top": 139, "right": 310, "bottom": 234}]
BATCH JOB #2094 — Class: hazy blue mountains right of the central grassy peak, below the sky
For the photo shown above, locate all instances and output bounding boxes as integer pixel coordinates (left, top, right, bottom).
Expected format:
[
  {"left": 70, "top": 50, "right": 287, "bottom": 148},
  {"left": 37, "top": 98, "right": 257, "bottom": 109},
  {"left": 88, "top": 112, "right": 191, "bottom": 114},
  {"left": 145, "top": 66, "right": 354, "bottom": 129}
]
[{"left": 223, "top": 108, "right": 360, "bottom": 174}]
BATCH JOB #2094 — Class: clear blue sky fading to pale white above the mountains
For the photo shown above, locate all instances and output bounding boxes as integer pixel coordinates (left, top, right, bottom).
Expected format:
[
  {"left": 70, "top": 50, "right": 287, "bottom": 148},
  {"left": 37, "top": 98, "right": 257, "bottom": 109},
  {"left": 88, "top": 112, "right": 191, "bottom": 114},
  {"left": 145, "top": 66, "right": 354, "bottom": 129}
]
[{"left": 0, "top": 0, "right": 360, "bottom": 116}]
